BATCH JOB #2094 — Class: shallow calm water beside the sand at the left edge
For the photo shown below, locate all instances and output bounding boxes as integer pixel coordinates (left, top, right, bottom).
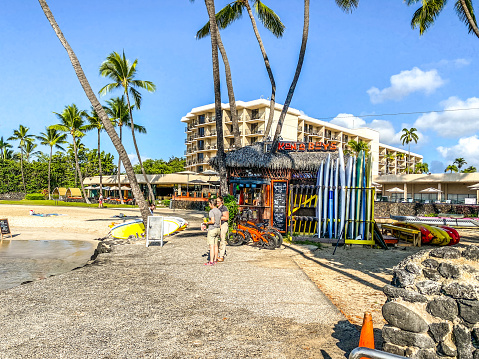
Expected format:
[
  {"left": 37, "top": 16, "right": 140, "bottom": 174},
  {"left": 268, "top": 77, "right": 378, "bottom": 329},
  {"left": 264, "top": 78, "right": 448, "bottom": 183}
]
[{"left": 0, "top": 239, "right": 96, "bottom": 290}]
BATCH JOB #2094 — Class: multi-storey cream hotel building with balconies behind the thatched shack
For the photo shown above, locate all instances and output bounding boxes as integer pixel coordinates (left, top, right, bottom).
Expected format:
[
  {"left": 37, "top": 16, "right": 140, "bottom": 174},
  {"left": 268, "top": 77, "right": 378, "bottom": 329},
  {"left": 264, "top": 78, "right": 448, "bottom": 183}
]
[{"left": 181, "top": 99, "right": 423, "bottom": 175}]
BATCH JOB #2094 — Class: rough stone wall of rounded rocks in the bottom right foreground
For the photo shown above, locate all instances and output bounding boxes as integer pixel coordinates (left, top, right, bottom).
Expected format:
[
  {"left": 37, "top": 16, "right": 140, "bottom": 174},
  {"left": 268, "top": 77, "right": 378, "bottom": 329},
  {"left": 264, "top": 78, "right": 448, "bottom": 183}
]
[{"left": 382, "top": 246, "right": 479, "bottom": 359}]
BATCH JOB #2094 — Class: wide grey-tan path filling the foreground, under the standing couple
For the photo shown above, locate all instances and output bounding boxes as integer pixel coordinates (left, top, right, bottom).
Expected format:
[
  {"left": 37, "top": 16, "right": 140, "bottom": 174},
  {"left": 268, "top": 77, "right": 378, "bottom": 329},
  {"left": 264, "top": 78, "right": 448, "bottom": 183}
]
[{"left": 0, "top": 224, "right": 358, "bottom": 359}]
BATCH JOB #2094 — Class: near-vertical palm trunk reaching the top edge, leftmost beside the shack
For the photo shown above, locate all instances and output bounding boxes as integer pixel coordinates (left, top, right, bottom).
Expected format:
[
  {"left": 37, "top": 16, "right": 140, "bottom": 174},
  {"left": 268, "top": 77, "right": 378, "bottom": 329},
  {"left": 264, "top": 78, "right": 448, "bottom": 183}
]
[{"left": 205, "top": 0, "right": 228, "bottom": 195}]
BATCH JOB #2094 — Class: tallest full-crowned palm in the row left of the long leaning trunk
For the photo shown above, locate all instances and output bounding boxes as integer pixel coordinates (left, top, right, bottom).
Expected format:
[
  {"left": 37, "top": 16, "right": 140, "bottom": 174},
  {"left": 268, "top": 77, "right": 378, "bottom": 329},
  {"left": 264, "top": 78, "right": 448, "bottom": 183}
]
[{"left": 51, "top": 104, "right": 92, "bottom": 204}]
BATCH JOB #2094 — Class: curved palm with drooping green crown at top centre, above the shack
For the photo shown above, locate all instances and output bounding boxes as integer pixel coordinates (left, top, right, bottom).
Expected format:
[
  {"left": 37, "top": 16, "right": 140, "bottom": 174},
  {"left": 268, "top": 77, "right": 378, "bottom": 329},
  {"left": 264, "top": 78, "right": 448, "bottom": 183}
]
[{"left": 196, "top": 0, "right": 285, "bottom": 142}]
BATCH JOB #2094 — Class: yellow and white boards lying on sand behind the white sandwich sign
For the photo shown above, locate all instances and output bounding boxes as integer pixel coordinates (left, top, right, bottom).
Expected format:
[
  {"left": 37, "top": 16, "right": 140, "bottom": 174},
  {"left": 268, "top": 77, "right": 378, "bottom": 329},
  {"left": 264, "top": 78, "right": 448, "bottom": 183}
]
[{"left": 108, "top": 217, "right": 188, "bottom": 239}]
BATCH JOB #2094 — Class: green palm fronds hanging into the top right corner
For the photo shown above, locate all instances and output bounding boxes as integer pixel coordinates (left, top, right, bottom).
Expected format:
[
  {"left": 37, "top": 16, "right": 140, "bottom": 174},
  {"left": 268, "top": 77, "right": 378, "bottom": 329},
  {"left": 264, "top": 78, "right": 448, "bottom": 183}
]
[{"left": 406, "top": 0, "right": 479, "bottom": 38}]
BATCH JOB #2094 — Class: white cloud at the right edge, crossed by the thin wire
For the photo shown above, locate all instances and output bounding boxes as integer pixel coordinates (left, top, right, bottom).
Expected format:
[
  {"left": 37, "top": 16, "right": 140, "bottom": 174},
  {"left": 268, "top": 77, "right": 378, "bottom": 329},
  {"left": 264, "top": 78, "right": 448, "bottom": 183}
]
[{"left": 414, "top": 97, "right": 479, "bottom": 137}]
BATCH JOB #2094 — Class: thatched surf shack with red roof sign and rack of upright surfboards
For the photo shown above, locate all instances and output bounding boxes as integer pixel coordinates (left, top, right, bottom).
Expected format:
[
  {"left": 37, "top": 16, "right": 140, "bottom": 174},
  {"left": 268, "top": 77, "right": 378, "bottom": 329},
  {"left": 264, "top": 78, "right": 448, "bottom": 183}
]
[{"left": 211, "top": 141, "right": 374, "bottom": 244}]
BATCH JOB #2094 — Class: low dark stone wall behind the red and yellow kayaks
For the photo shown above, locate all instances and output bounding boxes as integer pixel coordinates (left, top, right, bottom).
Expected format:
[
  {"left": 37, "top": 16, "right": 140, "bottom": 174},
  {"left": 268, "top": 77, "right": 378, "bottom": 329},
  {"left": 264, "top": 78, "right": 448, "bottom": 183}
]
[{"left": 374, "top": 202, "right": 479, "bottom": 217}]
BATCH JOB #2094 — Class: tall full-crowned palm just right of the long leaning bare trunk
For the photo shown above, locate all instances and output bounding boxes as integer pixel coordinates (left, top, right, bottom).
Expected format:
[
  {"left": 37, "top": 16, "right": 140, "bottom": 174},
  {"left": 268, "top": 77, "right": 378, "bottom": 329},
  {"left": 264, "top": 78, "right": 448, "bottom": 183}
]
[{"left": 99, "top": 51, "right": 156, "bottom": 201}]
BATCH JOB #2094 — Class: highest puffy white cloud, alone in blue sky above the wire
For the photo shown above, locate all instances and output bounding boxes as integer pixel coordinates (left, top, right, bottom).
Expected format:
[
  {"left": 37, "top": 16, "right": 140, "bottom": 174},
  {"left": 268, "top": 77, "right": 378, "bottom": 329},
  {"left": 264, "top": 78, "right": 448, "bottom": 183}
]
[{"left": 367, "top": 67, "right": 444, "bottom": 104}]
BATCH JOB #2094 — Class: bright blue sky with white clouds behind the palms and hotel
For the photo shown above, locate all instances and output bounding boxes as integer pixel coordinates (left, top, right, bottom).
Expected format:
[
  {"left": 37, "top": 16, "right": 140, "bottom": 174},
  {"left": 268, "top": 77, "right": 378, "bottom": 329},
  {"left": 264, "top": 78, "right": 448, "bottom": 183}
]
[{"left": 0, "top": 0, "right": 479, "bottom": 172}]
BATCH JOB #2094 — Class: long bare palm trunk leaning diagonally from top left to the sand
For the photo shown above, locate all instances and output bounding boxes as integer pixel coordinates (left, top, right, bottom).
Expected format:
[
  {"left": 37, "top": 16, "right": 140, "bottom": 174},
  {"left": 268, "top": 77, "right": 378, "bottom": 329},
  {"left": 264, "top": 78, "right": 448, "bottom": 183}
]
[{"left": 38, "top": 0, "right": 150, "bottom": 226}]
